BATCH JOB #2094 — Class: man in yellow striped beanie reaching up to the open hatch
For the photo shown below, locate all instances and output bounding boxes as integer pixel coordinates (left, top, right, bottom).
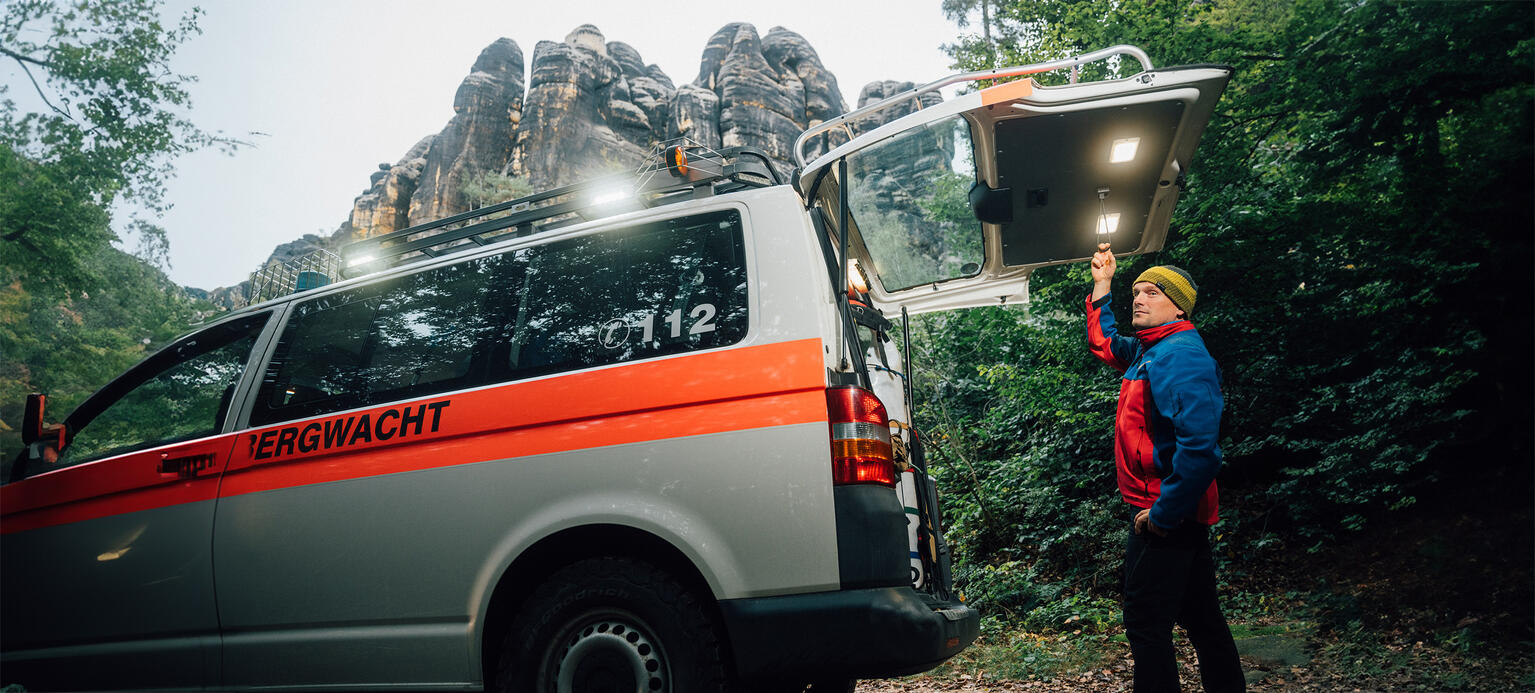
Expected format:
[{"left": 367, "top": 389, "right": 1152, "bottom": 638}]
[{"left": 1087, "top": 243, "right": 1246, "bottom": 693}]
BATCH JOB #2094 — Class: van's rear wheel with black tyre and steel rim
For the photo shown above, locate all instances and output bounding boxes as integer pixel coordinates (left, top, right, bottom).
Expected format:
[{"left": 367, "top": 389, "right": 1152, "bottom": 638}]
[{"left": 496, "top": 558, "right": 725, "bottom": 693}]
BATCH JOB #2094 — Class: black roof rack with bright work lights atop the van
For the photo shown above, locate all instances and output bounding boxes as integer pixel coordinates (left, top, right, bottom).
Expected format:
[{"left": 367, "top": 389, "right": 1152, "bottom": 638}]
[{"left": 341, "top": 138, "right": 783, "bottom": 277}]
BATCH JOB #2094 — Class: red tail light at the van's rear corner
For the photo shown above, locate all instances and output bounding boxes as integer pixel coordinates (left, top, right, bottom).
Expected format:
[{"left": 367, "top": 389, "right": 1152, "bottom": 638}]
[{"left": 826, "top": 387, "right": 900, "bottom": 487}]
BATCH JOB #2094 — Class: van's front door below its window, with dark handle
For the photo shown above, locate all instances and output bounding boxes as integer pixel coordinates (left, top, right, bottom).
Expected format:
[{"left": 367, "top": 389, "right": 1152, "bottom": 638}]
[{"left": 0, "top": 436, "right": 233, "bottom": 688}]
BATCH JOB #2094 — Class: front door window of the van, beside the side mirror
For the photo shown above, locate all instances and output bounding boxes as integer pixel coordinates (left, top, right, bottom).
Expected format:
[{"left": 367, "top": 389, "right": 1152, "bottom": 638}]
[{"left": 44, "top": 313, "right": 270, "bottom": 473}]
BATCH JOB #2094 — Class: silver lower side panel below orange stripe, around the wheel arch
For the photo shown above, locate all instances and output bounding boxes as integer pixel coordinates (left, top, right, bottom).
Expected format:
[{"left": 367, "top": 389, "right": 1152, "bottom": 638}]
[{"left": 215, "top": 423, "right": 837, "bottom": 687}]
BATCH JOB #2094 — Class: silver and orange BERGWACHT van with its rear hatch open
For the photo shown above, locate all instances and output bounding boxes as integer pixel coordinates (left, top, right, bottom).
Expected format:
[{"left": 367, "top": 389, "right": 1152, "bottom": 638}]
[{"left": 0, "top": 46, "right": 1231, "bottom": 693}]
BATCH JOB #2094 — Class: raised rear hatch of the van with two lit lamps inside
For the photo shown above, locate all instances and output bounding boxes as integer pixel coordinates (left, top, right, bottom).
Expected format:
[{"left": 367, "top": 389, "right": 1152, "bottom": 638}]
[{"left": 797, "top": 46, "right": 1231, "bottom": 315}]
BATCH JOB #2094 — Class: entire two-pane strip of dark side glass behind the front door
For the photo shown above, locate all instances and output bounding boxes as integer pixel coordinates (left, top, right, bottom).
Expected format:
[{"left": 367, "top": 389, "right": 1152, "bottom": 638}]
[{"left": 252, "top": 211, "right": 748, "bottom": 426}]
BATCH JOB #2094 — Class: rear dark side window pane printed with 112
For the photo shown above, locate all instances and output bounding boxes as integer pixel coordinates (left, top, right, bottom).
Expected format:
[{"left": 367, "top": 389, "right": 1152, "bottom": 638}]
[{"left": 496, "top": 211, "right": 748, "bottom": 378}]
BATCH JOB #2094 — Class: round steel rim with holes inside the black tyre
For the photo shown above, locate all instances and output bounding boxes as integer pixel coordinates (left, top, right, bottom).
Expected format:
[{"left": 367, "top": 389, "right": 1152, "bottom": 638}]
[{"left": 546, "top": 612, "right": 671, "bottom": 693}]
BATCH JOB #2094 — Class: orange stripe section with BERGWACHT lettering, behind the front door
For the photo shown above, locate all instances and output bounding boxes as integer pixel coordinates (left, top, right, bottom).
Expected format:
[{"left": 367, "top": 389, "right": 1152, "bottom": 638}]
[{"left": 220, "top": 340, "right": 826, "bottom": 498}]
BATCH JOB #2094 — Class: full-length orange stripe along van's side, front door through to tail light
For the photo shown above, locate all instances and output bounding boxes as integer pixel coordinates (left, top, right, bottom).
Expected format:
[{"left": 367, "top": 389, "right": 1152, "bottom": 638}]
[{"left": 0, "top": 338, "right": 827, "bottom": 533}]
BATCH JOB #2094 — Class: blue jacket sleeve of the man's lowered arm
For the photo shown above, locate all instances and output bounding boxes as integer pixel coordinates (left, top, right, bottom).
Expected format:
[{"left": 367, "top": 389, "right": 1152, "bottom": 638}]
[{"left": 1147, "top": 349, "right": 1223, "bottom": 529}]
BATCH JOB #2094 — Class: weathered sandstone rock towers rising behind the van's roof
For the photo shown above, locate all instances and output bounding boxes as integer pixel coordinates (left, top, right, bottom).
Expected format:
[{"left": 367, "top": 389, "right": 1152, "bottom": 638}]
[{"left": 201, "top": 23, "right": 938, "bottom": 308}]
